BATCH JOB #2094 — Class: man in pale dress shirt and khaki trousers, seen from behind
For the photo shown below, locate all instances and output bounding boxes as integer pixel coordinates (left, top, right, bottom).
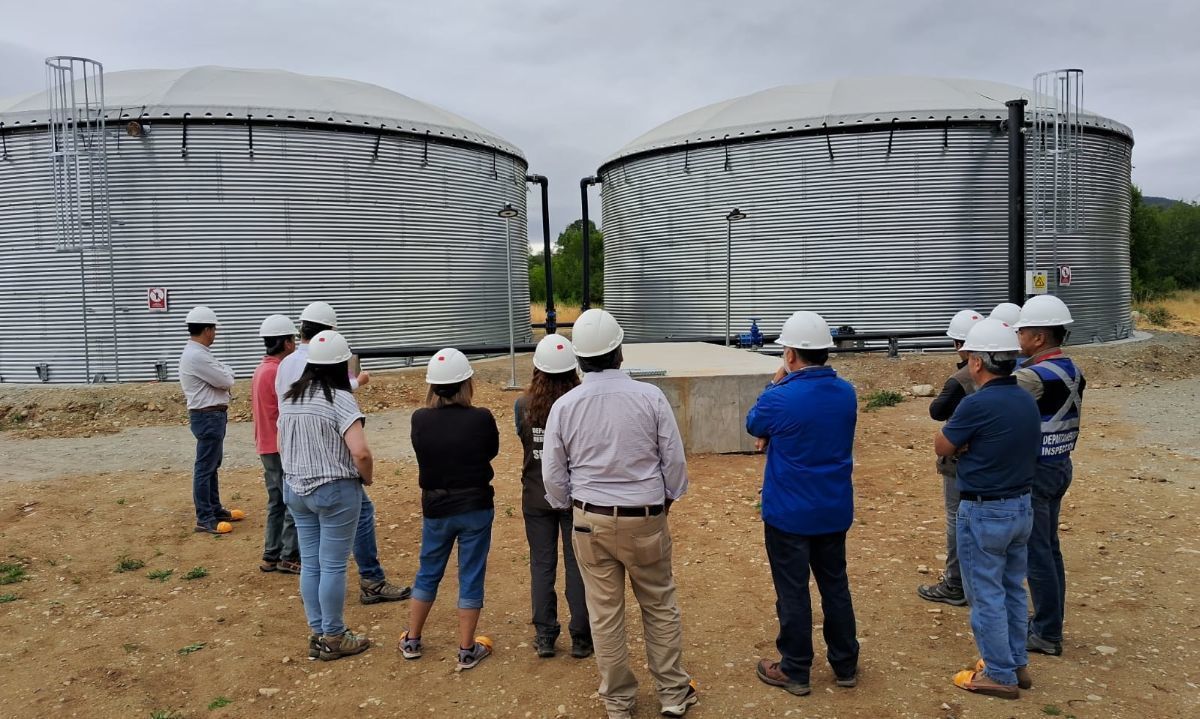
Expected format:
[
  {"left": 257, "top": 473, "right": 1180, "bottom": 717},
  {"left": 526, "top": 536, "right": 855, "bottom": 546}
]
[{"left": 541, "top": 310, "right": 697, "bottom": 719}]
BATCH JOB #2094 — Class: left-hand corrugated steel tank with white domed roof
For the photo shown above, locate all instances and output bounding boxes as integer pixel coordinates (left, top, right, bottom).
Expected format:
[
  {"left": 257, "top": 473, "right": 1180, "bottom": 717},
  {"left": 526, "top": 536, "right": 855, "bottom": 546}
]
[{"left": 0, "top": 67, "right": 530, "bottom": 382}]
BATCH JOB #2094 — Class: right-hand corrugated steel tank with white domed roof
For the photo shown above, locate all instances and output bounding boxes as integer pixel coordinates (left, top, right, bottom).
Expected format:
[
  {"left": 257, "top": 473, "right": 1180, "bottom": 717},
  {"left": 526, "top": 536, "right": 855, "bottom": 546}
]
[{"left": 599, "top": 78, "right": 1133, "bottom": 342}]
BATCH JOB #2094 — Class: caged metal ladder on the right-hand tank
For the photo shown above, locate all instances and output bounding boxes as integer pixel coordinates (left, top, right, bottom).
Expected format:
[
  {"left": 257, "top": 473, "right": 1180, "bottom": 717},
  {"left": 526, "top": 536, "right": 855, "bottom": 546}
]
[{"left": 1030, "top": 68, "right": 1084, "bottom": 289}]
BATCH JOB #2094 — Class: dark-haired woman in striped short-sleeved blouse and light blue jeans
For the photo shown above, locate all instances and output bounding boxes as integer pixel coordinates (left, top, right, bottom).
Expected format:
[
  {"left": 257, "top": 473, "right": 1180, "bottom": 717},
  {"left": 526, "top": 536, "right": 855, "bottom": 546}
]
[{"left": 278, "top": 330, "right": 374, "bottom": 661}]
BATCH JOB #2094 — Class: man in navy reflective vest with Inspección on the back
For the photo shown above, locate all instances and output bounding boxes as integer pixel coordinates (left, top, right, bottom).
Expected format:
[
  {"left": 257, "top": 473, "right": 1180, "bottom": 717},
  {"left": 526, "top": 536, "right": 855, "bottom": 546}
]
[{"left": 1016, "top": 294, "right": 1087, "bottom": 657}]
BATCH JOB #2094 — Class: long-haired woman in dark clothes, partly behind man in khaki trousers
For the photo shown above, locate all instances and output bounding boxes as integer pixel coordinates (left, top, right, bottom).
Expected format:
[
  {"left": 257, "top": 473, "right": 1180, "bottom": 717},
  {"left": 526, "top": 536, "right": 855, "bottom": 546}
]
[{"left": 514, "top": 335, "right": 593, "bottom": 659}]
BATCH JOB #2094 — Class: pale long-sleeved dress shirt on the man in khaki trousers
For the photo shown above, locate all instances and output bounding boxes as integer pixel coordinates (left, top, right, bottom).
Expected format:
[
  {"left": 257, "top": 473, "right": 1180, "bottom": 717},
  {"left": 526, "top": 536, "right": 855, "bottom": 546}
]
[{"left": 541, "top": 370, "right": 688, "bottom": 509}]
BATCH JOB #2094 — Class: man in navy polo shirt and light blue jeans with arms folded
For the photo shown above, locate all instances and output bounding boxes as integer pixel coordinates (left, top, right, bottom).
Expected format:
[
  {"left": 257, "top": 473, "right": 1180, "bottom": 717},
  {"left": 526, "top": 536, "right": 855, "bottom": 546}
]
[{"left": 934, "top": 318, "right": 1039, "bottom": 699}]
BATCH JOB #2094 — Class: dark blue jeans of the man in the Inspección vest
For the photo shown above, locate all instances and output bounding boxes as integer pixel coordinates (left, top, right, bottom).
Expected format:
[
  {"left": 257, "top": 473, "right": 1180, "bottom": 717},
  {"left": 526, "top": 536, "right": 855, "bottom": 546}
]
[{"left": 1030, "top": 459, "right": 1073, "bottom": 642}]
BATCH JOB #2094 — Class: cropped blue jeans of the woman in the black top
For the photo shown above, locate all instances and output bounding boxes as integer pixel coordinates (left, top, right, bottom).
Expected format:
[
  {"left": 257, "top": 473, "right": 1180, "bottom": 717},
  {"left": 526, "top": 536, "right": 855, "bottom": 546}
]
[{"left": 413, "top": 509, "right": 496, "bottom": 609}]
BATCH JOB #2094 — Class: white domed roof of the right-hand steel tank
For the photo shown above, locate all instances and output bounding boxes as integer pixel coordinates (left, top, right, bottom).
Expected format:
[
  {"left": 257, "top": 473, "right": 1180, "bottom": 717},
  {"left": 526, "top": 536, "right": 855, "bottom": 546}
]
[{"left": 604, "top": 77, "right": 1133, "bottom": 164}]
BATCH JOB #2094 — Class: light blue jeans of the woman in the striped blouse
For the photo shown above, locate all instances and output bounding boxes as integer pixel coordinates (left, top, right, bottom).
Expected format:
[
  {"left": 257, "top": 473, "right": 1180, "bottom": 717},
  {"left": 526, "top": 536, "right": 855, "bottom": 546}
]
[{"left": 283, "top": 479, "right": 362, "bottom": 636}]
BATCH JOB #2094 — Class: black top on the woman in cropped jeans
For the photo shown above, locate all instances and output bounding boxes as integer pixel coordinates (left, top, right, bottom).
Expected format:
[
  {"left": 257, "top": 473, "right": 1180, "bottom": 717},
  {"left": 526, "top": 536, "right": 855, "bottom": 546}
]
[{"left": 412, "top": 406, "right": 500, "bottom": 519}]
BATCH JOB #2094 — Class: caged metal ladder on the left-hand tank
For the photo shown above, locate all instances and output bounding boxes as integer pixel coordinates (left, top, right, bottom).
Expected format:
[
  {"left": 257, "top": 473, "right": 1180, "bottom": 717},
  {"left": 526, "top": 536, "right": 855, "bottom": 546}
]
[{"left": 40, "top": 55, "right": 121, "bottom": 383}]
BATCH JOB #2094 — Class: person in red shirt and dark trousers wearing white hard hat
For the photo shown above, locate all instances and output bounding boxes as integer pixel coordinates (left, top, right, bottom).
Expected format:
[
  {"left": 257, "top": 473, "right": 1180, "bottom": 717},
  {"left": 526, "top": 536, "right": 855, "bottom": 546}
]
[{"left": 250, "top": 314, "right": 300, "bottom": 574}]
